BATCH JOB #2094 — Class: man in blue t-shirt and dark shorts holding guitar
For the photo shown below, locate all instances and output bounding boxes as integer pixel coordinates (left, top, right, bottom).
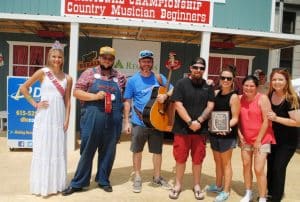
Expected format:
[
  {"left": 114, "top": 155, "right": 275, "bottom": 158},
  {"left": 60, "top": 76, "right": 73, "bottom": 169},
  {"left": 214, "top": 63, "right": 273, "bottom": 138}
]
[{"left": 124, "top": 50, "right": 172, "bottom": 193}]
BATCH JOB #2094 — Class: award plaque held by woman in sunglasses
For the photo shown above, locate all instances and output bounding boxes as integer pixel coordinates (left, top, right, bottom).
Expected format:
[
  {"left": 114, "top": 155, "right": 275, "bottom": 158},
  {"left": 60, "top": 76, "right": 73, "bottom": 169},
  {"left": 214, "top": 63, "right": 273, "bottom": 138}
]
[{"left": 210, "top": 111, "right": 230, "bottom": 133}]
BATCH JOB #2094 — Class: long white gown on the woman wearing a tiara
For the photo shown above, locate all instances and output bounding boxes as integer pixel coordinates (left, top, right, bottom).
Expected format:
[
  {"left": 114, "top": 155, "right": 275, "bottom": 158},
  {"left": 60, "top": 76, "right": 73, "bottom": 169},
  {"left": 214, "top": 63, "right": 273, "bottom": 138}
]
[{"left": 30, "top": 68, "right": 67, "bottom": 196}]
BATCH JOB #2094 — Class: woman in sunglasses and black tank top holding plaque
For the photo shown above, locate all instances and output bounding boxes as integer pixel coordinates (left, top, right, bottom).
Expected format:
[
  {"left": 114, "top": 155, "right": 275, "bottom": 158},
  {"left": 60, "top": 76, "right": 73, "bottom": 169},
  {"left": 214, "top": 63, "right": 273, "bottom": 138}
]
[{"left": 207, "top": 66, "right": 240, "bottom": 202}]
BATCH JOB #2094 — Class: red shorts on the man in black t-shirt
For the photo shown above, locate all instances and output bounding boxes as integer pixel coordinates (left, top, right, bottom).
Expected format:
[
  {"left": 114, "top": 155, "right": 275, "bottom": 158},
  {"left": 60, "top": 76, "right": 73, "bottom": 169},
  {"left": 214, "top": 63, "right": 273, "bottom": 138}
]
[{"left": 173, "top": 134, "right": 206, "bottom": 165}]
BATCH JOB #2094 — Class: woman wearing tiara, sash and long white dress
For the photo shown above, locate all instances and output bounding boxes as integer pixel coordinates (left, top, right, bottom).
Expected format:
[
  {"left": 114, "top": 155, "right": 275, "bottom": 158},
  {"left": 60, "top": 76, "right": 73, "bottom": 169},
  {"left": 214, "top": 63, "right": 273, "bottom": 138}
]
[{"left": 20, "top": 41, "right": 72, "bottom": 196}]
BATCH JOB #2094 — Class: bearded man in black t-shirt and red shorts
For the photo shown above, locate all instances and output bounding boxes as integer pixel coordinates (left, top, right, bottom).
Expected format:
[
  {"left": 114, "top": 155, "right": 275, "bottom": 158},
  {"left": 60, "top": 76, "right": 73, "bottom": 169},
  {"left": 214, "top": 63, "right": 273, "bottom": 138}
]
[{"left": 169, "top": 57, "right": 214, "bottom": 200}]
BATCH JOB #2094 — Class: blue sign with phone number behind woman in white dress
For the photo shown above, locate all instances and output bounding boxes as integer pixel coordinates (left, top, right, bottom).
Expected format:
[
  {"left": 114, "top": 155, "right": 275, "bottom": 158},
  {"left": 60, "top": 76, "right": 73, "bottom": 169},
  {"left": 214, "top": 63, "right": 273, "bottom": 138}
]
[{"left": 7, "top": 76, "right": 41, "bottom": 149}]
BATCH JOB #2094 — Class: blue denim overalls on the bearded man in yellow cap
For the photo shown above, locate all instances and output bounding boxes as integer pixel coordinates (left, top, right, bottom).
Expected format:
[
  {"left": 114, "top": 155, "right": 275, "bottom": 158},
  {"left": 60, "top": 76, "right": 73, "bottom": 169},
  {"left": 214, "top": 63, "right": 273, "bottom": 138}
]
[{"left": 71, "top": 68, "right": 123, "bottom": 188}]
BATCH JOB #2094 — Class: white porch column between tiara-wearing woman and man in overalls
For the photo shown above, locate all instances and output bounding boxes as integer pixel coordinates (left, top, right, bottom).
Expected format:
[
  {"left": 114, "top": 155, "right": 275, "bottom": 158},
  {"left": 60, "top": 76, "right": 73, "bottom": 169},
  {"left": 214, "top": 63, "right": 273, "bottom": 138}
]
[{"left": 68, "top": 22, "right": 79, "bottom": 151}]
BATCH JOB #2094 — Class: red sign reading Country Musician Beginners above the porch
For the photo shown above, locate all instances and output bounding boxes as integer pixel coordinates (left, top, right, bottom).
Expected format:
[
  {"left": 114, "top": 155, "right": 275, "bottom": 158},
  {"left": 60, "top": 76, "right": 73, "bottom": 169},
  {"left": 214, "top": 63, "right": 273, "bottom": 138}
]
[{"left": 61, "top": 0, "right": 211, "bottom": 24}]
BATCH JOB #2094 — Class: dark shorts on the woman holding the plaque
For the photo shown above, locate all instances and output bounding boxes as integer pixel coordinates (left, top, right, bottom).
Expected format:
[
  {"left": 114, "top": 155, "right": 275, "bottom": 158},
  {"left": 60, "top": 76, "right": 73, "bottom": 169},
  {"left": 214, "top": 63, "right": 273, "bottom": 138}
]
[{"left": 209, "top": 135, "right": 237, "bottom": 152}]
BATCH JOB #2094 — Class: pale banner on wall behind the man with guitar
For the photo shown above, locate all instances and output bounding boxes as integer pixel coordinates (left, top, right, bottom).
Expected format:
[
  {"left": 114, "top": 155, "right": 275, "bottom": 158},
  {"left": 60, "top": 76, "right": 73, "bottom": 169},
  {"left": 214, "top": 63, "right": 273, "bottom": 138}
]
[{"left": 112, "top": 39, "right": 161, "bottom": 76}]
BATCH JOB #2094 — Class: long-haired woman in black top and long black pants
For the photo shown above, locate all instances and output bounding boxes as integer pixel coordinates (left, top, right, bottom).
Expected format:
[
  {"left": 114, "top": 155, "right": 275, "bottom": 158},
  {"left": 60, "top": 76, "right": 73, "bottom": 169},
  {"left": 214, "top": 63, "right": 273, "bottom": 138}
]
[{"left": 267, "top": 68, "right": 300, "bottom": 202}]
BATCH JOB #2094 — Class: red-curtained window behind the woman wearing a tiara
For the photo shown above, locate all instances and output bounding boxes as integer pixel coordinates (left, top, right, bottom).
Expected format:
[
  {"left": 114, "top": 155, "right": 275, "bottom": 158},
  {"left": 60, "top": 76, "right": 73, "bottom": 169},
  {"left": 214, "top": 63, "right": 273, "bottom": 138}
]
[{"left": 8, "top": 41, "right": 52, "bottom": 76}]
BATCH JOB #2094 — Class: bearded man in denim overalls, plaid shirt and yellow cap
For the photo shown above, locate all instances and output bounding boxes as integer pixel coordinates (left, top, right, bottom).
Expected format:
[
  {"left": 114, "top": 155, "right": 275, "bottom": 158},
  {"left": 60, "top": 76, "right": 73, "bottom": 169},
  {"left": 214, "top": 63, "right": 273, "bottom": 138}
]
[{"left": 62, "top": 46, "right": 126, "bottom": 196}]
